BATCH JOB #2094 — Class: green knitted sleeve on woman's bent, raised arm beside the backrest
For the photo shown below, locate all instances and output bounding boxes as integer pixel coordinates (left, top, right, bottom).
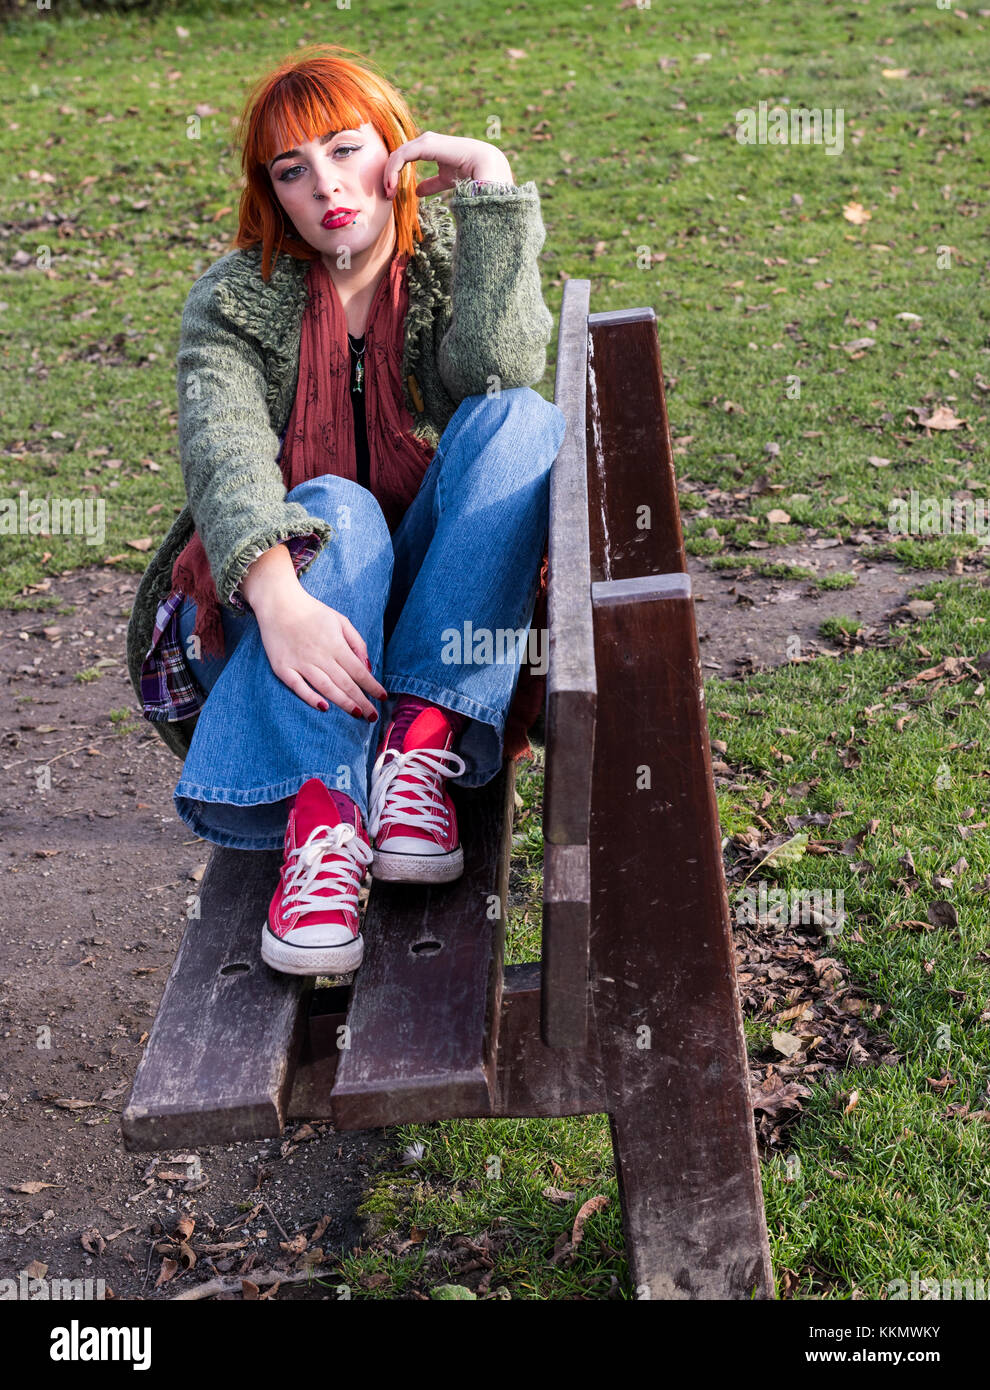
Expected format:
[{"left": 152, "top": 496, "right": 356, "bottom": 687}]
[{"left": 438, "top": 179, "right": 553, "bottom": 402}]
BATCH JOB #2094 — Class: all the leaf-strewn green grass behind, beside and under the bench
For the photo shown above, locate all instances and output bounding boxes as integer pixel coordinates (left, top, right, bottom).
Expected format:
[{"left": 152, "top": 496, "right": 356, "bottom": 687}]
[{"left": 0, "top": 0, "right": 990, "bottom": 1298}]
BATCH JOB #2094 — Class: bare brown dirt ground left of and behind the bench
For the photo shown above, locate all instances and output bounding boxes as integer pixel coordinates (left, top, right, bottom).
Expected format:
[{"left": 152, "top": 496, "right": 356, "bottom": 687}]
[{"left": 0, "top": 546, "right": 945, "bottom": 1298}]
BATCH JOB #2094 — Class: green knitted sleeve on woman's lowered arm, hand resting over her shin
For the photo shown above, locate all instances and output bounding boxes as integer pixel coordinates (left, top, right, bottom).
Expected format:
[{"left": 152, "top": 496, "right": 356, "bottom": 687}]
[{"left": 177, "top": 263, "right": 334, "bottom": 612}]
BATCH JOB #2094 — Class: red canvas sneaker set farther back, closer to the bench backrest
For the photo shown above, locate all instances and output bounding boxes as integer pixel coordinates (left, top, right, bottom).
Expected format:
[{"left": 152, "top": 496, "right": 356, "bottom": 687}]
[{"left": 368, "top": 701, "right": 467, "bottom": 883}]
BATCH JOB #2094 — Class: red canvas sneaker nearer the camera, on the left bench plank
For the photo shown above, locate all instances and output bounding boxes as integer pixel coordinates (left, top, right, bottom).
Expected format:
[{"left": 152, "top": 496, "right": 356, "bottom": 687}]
[{"left": 261, "top": 777, "right": 371, "bottom": 974}]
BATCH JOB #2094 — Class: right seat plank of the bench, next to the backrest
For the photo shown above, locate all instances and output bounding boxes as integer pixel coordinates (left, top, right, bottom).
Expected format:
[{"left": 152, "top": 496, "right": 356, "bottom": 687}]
[{"left": 330, "top": 763, "right": 514, "bottom": 1130}]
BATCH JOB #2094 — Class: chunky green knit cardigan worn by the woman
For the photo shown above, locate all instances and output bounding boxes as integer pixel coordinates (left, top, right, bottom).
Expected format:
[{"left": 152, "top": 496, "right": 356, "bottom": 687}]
[{"left": 127, "top": 179, "right": 553, "bottom": 759}]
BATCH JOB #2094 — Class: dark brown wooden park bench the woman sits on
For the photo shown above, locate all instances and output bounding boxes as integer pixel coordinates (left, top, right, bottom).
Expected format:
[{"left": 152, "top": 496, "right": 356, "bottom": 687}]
[{"left": 122, "top": 279, "right": 773, "bottom": 1300}]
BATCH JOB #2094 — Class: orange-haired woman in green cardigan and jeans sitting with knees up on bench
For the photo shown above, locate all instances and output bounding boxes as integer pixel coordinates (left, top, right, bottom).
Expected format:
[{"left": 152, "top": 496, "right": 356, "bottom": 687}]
[{"left": 128, "top": 44, "right": 565, "bottom": 974}]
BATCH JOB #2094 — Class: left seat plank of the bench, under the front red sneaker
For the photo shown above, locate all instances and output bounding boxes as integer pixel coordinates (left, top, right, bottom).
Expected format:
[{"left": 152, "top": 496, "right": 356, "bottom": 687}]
[{"left": 121, "top": 847, "right": 313, "bottom": 1150}]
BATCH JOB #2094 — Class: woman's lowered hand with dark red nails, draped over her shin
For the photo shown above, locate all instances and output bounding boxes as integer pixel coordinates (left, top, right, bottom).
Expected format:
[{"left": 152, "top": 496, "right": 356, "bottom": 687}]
[{"left": 256, "top": 585, "right": 388, "bottom": 719}]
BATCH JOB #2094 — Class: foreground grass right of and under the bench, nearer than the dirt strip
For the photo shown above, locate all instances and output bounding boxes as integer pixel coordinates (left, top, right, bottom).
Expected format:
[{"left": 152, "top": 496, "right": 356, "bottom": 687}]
[{"left": 342, "top": 582, "right": 990, "bottom": 1298}]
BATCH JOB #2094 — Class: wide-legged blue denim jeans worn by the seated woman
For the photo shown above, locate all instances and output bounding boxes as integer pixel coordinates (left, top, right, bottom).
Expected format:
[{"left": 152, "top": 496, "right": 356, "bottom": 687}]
[{"left": 174, "top": 386, "right": 565, "bottom": 849}]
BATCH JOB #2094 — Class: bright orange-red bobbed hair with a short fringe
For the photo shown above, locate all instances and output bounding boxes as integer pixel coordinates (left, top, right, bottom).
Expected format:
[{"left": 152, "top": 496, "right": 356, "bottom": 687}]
[{"left": 231, "top": 43, "right": 423, "bottom": 281}]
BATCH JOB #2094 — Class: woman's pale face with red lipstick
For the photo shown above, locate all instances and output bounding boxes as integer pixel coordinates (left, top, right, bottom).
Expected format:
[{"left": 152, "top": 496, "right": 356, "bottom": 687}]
[{"left": 268, "top": 122, "right": 395, "bottom": 259}]
